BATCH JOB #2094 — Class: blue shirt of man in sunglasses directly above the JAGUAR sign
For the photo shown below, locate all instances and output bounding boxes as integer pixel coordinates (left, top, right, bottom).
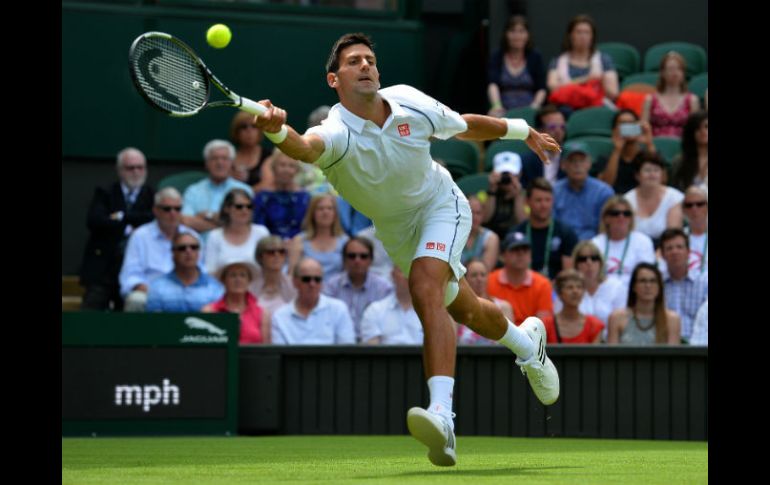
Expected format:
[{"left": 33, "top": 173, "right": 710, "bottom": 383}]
[{"left": 145, "top": 269, "right": 225, "bottom": 313}]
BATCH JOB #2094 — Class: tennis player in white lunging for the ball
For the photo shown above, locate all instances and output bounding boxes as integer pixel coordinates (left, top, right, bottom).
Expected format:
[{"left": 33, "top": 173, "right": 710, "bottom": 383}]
[{"left": 256, "top": 33, "right": 560, "bottom": 466}]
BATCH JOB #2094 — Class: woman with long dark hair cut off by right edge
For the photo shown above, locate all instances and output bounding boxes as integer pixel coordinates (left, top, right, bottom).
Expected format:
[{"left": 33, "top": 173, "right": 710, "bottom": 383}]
[{"left": 671, "top": 111, "right": 709, "bottom": 190}]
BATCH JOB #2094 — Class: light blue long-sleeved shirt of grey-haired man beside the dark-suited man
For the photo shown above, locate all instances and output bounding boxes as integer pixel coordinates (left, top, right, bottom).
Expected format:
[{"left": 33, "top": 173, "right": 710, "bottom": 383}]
[{"left": 119, "top": 221, "right": 204, "bottom": 298}]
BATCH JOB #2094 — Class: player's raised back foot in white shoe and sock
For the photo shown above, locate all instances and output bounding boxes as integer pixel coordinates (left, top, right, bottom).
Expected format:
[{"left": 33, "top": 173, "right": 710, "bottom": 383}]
[{"left": 516, "top": 317, "right": 559, "bottom": 405}]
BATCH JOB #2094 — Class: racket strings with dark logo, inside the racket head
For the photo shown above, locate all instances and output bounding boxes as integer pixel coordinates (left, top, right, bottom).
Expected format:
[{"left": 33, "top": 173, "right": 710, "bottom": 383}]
[{"left": 133, "top": 37, "right": 208, "bottom": 113}]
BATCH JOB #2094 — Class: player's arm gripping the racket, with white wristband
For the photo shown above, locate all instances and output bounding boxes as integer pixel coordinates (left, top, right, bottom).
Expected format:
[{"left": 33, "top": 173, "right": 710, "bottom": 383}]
[{"left": 255, "top": 99, "right": 325, "bottom": 163}]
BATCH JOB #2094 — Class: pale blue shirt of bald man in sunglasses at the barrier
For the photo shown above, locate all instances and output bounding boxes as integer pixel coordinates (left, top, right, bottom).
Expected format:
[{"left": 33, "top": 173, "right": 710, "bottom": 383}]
[{"left": 272, "top": 294, "right": 356, "bottom": 345}]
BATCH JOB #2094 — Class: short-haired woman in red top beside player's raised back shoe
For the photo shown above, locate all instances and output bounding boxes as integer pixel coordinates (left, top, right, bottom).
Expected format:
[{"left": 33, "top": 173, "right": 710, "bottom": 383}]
[{"left": 543, "top": 269, "right": 604, "bottom": 344}]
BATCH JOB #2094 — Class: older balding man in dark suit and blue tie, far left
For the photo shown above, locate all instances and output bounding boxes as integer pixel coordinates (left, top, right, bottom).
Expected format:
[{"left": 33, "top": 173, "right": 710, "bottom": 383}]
[{"left": 80, "top": 147, "right": 155, "bottom": 311}]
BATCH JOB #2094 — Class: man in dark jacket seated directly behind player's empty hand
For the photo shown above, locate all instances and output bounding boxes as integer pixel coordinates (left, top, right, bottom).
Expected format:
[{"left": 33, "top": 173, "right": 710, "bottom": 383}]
[{"left": 519, "top": 104, "right": 567, "bottom": 187}]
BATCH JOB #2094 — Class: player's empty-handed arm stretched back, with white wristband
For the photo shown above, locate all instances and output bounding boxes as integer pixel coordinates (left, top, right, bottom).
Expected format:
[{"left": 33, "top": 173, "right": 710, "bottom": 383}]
[{"left": 457, "top": 113, "right": 561, "bottom": 164}]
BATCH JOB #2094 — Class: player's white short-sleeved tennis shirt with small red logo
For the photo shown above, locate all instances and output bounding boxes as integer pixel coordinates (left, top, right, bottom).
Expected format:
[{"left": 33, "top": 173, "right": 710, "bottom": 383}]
[{"left": 306, "top": 84, "right": 468, "bottom": 222}]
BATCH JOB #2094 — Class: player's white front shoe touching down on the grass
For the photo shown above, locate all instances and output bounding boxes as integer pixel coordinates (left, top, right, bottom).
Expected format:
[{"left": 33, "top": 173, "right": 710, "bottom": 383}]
[{"left": 406, "top": 407, "right": 457, "bottom": 466}]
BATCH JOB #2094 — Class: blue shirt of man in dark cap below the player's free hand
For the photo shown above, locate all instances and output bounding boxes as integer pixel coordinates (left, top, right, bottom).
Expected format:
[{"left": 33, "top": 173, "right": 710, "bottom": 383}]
[{"left": 553, "top": 177, "right": 615, "bottom": 241}]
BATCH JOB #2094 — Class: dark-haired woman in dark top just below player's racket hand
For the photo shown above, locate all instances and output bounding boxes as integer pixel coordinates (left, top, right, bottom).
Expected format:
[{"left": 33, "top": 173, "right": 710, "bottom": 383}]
[{"left": 230, "top": 111, "right": 273, "bottom": 193}]
